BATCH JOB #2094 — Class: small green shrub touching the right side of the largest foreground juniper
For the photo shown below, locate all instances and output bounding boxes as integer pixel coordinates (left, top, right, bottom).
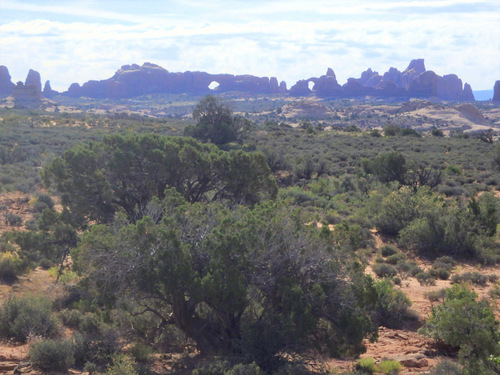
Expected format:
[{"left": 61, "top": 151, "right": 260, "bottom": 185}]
[{"left": 375, "top": 280, "right": 411, "bottom": 328}]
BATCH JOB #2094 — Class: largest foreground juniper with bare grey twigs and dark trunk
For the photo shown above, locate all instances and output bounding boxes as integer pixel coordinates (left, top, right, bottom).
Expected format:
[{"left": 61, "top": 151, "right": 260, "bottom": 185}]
[{"left": 73, "top": 202, "right": 376, "bottom": 369}]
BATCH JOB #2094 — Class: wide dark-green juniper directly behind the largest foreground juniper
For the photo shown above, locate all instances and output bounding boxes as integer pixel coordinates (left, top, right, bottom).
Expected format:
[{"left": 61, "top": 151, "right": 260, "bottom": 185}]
[{"left": 43, "top": 134, "right": 277, "bottom": 223}]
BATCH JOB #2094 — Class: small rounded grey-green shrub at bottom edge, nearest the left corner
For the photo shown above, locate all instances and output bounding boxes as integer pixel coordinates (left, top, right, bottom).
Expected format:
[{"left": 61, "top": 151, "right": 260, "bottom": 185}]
[{"left": 30, "top": 340, "right": 74, "bottom": 372}]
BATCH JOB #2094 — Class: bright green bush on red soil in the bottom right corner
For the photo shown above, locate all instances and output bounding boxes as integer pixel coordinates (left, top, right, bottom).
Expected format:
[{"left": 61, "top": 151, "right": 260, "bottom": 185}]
[{"left": 419, "top": 285, "right": 500, "bottom": 366}]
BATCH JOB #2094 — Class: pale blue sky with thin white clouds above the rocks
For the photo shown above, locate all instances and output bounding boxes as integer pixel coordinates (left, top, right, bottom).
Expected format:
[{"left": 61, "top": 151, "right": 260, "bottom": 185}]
[{"left": 0, "top": 0, "right": 500, "bottom": 91}]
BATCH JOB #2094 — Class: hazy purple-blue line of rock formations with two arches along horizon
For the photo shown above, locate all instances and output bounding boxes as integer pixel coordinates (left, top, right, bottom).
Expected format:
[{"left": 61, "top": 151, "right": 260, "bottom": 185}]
[{"left": 0, "top": 59, "right": 488, "bottom": 105}]
